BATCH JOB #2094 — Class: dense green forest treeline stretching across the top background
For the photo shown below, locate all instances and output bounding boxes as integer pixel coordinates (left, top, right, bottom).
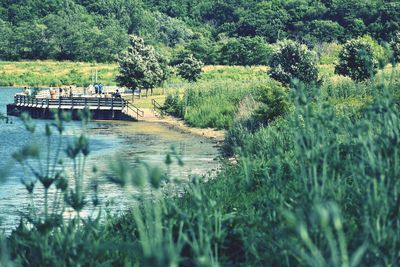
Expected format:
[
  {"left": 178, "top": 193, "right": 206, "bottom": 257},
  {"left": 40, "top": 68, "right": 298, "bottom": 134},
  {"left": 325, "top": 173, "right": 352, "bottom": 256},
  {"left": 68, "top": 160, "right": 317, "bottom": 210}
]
[{"left": 0, "top": 0, "right": 400, "bottom": 65}]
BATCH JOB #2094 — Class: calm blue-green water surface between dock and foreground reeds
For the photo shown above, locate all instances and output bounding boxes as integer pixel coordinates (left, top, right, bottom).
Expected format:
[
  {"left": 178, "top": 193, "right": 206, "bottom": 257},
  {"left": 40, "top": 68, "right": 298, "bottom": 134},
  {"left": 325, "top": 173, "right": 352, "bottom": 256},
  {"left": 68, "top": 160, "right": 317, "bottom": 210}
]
[{"left": 0, "top": 89, "right": 218, "bottom": 231}]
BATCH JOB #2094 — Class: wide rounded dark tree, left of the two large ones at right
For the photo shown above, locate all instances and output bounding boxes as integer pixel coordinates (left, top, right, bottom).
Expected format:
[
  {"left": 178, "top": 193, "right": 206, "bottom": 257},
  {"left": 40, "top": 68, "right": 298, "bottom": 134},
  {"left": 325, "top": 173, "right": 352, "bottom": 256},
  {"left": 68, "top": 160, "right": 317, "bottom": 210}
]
[{"left": 268, "top": 40, "right": 318, "bottom": 85}]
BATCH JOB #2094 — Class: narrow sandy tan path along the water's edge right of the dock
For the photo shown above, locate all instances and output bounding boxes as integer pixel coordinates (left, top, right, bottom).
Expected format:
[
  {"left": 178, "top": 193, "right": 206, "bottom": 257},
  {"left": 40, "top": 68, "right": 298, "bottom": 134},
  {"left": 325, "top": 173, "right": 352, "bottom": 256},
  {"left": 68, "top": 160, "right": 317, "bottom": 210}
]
[{"left": 140, "top": 109, "right": 225, "bottom": 142}]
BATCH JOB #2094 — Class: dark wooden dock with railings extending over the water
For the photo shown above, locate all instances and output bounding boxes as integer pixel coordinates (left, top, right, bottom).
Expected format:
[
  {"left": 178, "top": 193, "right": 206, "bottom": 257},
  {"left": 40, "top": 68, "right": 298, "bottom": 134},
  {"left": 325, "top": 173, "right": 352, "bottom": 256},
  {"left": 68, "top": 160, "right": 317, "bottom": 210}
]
[{"left": 7, "top": 95, "right": 144, "bottom": 121}]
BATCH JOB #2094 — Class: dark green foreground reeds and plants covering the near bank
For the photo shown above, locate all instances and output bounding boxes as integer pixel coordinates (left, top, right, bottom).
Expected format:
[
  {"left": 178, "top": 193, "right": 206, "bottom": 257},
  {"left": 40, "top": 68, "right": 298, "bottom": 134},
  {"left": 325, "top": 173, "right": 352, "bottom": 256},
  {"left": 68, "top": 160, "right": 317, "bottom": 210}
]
[{"left": 2, "top": 65, "right": 400, "bottom": 266}]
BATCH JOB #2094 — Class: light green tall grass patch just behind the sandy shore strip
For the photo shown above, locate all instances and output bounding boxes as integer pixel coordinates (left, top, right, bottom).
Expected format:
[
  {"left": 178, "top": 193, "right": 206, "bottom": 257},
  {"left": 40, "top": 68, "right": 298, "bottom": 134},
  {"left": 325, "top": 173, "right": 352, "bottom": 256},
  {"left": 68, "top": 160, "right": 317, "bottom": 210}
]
[{"left": 165, "top": 67, "right": 272, "bottom": 129}]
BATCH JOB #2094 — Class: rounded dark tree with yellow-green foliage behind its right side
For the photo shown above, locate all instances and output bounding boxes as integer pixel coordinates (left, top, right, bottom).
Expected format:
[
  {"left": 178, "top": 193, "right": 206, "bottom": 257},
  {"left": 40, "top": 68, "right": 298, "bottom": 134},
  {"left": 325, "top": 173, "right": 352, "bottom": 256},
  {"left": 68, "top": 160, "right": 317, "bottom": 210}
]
[{"left": 335, "top": 39, "right": 377, "bottom": 82}]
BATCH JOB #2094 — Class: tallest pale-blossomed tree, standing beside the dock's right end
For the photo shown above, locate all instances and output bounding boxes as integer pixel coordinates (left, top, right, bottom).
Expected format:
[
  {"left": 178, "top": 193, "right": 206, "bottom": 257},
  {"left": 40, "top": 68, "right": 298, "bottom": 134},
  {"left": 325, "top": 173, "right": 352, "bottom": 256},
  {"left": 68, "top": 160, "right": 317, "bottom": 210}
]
[{"left": 116, "top": 35, "right": 167, "bottom": 96}]
